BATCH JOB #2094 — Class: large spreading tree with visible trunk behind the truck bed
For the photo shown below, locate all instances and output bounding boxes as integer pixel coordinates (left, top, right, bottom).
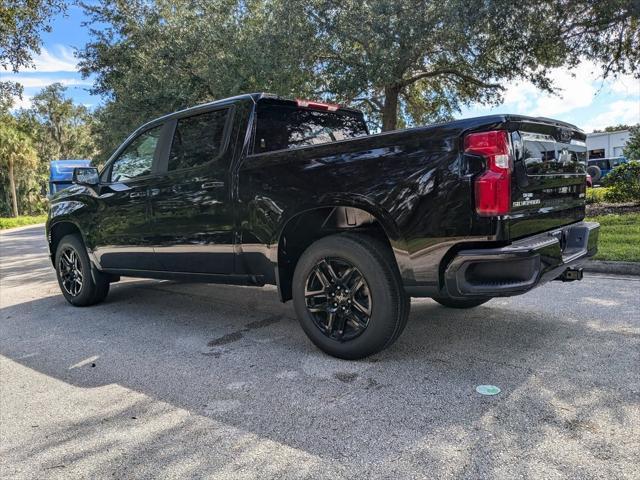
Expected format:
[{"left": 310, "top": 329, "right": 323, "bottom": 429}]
[{"left": 310, "top": 0, "right": 640, "bottom": 130}]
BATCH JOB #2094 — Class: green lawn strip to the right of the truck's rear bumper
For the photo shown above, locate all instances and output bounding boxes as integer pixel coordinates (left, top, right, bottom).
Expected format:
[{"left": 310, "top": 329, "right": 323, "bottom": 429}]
[{"left": 588, "top": 213, "right": 640, "bottom": 262}]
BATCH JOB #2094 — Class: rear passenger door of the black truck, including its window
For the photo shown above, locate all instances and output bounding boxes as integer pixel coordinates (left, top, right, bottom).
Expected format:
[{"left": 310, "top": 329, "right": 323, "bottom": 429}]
[{"left": 149, "top": 107, "right": 235, "bottom": 274}]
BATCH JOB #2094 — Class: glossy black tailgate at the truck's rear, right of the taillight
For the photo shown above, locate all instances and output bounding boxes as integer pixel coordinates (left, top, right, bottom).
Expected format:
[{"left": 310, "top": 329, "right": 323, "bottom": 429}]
[{"left": 507, "top": 119, "right": 587, "bottom": 239}]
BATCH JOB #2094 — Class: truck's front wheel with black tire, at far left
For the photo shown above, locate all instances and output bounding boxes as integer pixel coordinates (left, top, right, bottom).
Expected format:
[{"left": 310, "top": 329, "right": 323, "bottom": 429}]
[{"left": 55, "top": 234, "right": 109, "bottom": 307}]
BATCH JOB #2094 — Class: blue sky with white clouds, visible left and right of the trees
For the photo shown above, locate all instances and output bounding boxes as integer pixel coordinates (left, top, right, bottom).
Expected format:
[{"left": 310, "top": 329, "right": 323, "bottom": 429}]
[{"left": 0, "top": 5, "right": 640, "bottom": 132}]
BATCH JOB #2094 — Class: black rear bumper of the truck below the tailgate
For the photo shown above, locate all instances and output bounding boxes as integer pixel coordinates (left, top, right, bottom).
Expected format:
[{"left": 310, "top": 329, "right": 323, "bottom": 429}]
[{"left": 444, "top": 222, "right": 600, "bottom": 298}]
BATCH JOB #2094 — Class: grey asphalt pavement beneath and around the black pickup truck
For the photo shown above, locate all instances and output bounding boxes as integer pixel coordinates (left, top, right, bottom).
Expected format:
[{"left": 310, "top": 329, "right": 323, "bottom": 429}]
[{"left": 0, "top": 227, "right": 640, "bottom": 480}]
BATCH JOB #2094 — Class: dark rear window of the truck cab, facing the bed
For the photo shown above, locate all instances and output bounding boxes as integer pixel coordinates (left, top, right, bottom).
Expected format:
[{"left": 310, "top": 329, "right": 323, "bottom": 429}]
[{"left": 254, "top": 102, "right": 367, "bottom": 153}]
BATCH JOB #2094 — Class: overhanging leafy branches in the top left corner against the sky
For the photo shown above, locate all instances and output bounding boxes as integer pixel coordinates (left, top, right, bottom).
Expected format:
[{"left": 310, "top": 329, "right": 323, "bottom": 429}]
[{"left": 0, "top": 0, "right": 66, "bottom": 102}]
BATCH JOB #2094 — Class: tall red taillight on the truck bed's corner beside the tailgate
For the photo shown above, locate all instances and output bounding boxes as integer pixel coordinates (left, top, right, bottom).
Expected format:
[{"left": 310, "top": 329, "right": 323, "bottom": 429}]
[{"left": 464, "top": 130, "right": 511, "bottom": 217}]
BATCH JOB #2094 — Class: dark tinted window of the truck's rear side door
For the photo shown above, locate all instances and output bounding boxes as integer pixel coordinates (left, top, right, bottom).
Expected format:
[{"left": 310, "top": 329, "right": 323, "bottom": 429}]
[{"left": 167, "top": 109, "right": 229, "bottom": 171}]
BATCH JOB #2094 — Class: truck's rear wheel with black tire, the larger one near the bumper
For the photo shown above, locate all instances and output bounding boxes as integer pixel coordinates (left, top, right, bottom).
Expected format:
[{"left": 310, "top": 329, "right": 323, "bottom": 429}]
[{"left": 293, "top": 233, "right": 411, "bottom": 360}]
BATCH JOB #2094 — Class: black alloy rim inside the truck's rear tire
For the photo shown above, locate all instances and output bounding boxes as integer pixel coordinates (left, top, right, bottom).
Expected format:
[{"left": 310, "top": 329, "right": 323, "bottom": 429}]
[{"left": 304, "top": 258, "right": 372, "bottom": 342}]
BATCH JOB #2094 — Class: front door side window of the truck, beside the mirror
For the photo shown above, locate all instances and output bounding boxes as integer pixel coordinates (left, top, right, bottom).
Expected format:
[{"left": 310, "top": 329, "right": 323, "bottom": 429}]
[{"left": 111, "top": 125, "right": 162, "bottom": 182}]
